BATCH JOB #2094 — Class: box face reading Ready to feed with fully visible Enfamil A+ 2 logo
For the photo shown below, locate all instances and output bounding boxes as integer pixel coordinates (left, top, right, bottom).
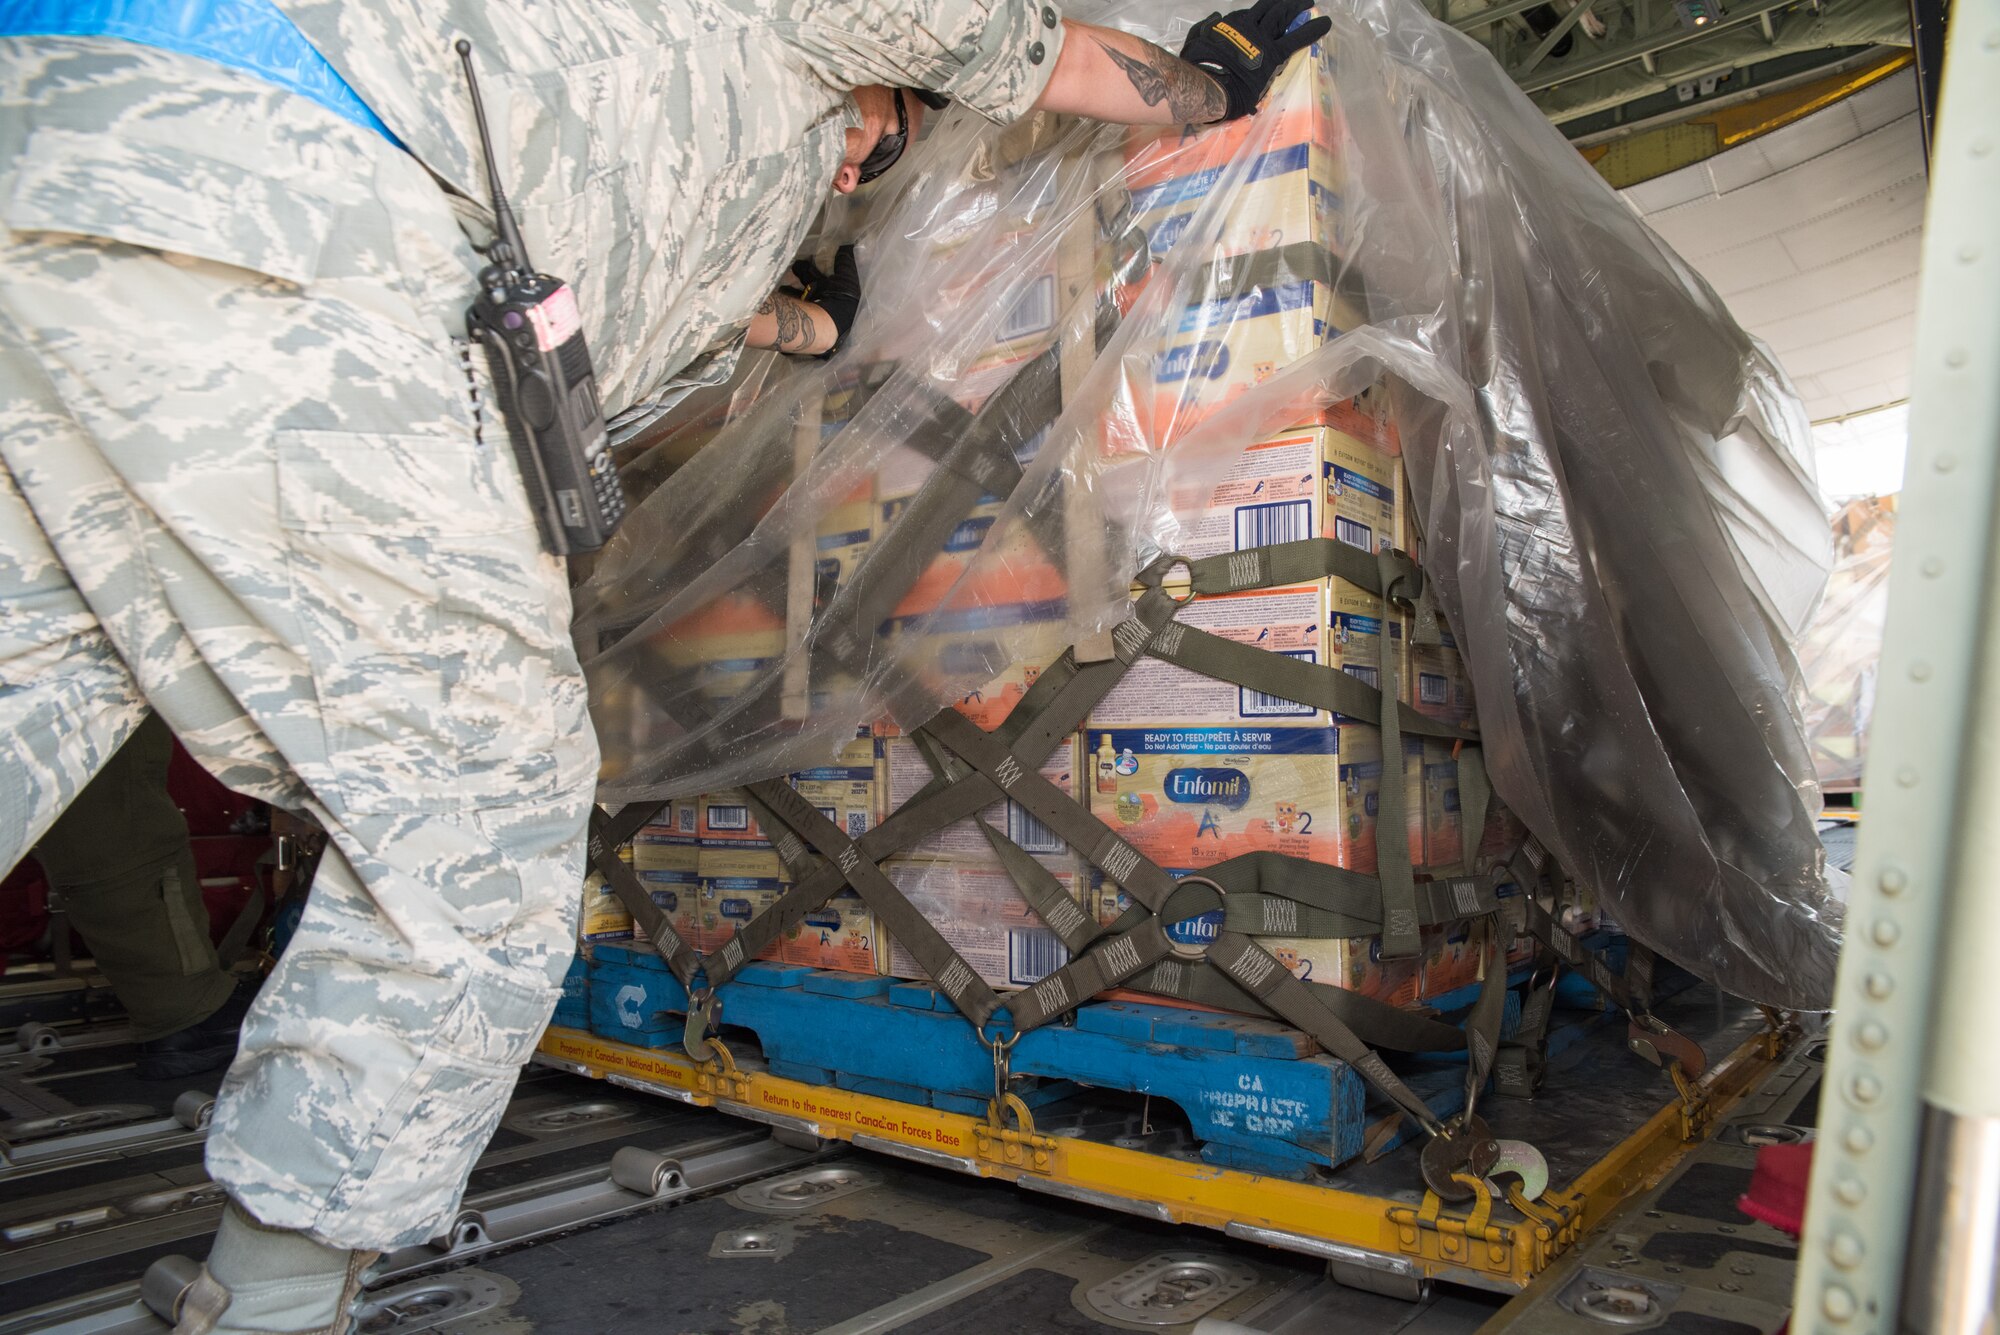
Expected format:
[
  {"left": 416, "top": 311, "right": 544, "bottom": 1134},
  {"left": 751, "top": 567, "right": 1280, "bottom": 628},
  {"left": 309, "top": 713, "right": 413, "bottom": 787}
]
[{"left": 1084, "top": 723, "right": 1382, "bottom": 871}]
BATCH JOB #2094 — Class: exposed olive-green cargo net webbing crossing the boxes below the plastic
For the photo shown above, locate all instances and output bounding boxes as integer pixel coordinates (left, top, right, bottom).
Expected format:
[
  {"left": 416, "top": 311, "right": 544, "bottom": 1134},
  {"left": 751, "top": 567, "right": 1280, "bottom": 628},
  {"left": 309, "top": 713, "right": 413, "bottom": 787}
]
[{"left": 592, "top": 543, "right": 1576, "bottom": 1135}]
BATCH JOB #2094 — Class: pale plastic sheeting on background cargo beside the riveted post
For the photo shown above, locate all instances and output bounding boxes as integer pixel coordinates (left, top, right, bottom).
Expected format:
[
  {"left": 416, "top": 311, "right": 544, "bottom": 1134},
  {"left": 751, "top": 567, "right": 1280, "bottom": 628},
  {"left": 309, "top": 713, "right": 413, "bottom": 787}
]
[{"left": 1798, "top": 496, "right": 1896, "bottom": 789}]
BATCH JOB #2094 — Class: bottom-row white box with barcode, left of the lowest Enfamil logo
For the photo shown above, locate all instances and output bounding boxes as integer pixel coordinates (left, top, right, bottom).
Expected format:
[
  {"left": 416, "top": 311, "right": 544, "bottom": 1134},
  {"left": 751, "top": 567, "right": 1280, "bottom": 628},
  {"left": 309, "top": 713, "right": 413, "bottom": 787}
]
[{"left": 882, "top": 857, "right": 1082, "bottom": 987}]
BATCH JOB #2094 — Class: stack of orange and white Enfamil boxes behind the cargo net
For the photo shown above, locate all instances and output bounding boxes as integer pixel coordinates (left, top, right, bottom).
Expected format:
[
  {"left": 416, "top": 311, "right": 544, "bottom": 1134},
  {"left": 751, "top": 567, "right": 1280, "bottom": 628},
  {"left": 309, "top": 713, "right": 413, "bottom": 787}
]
[{"left": 584, "top": 28, "right": 1552, "bottom": 1003}]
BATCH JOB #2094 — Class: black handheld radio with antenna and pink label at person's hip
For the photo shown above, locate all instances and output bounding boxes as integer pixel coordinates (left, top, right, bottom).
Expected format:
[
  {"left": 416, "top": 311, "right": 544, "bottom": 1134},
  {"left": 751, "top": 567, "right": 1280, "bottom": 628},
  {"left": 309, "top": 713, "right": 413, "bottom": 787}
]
[{"left": 458, "top": 40, "right": 626, "bottom": 556}]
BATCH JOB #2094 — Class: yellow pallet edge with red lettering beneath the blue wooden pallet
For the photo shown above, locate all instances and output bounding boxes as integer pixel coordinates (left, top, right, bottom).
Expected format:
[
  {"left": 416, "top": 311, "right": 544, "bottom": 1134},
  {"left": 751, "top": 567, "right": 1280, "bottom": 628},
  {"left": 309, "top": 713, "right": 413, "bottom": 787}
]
[{"left": 536, "top": 1025, "right": 1796, "bottom": 1293}]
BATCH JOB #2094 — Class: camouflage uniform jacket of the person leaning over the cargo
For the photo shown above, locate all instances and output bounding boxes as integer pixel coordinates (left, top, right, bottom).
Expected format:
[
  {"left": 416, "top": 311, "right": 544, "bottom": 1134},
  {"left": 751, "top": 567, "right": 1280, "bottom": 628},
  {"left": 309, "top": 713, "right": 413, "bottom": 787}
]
[{"left": 280, "top": 0, "right": 1062, "bottom": 414}]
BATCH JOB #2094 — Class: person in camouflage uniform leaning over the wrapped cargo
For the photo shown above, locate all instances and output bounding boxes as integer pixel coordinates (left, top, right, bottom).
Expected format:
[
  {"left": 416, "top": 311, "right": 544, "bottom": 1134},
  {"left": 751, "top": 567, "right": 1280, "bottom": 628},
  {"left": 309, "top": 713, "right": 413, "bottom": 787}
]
[{"left": 0, "top": 0, "right": 1310, "bottom": 1331}]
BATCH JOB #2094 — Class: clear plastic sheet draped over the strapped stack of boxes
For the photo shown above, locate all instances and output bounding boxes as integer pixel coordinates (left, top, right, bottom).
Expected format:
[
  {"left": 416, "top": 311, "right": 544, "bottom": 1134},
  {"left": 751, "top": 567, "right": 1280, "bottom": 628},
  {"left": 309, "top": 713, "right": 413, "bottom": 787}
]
[{"left": 578, "top": 0, "right": 1840, "bottom": 1007}]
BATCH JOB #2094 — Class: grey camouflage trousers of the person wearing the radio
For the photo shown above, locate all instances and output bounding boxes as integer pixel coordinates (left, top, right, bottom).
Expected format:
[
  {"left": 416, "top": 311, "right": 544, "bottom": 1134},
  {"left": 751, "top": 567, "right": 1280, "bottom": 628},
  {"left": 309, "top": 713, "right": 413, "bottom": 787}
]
[{"left": 0, "top": 38, "right": 598, "bottom": 1247}]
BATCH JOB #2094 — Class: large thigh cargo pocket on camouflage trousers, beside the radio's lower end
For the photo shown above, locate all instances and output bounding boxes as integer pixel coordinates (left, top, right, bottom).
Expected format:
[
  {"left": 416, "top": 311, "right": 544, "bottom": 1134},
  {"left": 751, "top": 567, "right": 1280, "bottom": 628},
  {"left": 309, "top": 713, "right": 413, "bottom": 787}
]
[{"left": 276, "top": 432, "right": 570, "bottom": 813}]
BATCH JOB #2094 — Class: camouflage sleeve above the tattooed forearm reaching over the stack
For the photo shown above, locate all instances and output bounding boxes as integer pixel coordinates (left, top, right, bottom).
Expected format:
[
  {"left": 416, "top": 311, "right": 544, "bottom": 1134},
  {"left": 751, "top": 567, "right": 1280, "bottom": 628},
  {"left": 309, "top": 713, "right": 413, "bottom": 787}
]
[{"left": 782, "top": 0, "right": 1062, "bottom": 122}]
